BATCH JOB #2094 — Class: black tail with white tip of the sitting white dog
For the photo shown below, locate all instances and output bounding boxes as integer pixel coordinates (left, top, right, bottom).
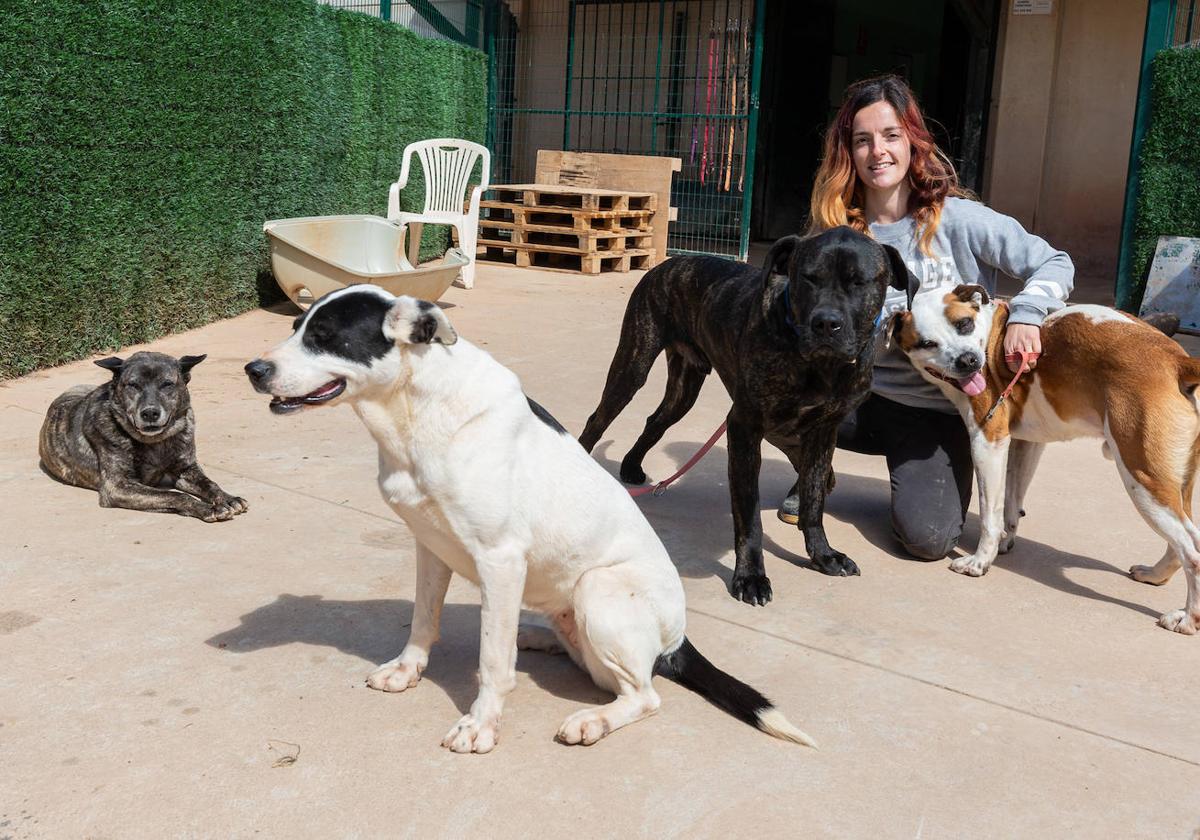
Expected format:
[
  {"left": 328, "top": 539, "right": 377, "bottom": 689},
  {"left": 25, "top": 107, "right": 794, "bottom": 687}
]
[{"left": 654, "top": 637, "right": 817, "bottom": 748}]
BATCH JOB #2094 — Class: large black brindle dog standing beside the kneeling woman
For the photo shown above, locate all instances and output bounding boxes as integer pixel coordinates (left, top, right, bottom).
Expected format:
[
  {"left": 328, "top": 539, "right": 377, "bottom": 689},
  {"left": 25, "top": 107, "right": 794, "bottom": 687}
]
[{"left": 580, "top": 227, "right": 908, "bottom": 605}]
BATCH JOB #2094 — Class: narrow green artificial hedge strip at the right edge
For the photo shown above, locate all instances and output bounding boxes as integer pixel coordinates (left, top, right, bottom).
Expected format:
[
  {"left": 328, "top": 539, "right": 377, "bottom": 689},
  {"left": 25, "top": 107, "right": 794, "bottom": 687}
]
[{"left": 1133, "top": 47, "right": 1200, "bottom": 301}]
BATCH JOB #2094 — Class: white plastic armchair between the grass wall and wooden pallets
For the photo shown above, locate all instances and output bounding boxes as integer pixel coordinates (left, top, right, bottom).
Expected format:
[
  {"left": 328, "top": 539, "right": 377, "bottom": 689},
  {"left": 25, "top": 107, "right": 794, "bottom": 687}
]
[{"left": 388, "top": 137, "right": 492, "bottom": 289}]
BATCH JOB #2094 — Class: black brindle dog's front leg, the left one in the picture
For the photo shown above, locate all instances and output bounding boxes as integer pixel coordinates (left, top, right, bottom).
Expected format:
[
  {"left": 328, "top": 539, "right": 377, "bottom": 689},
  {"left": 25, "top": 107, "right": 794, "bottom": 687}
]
[{"left": 726, "top": 413, "right": 772, "bottom": 606}]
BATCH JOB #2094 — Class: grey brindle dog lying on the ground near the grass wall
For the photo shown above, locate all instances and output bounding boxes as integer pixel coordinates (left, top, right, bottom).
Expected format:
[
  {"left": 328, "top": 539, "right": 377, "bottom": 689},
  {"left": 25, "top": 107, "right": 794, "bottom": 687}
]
[{"left": 38, "top": 353, "right": 247, "bottom": 522}]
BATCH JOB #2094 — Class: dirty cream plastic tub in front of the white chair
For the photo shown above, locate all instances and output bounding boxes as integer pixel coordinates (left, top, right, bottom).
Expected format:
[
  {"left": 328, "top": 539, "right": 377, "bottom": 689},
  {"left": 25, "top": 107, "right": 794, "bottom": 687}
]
[{"left": 263, "top": 216, "right": 467, "bottom": 308}]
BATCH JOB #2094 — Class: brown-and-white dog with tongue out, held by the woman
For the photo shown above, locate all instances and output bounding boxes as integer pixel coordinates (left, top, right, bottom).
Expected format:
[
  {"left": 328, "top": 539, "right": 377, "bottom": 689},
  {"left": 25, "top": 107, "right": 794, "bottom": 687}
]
[{"left": 892, "top": 286, "right": 1200, "bottom": 635}]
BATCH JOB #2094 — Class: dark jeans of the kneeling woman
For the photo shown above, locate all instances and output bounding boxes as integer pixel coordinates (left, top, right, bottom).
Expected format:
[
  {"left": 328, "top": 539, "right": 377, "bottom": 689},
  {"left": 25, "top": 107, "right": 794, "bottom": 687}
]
[{"left": 838, "top": 394, "right": 974, "bottom": 560}]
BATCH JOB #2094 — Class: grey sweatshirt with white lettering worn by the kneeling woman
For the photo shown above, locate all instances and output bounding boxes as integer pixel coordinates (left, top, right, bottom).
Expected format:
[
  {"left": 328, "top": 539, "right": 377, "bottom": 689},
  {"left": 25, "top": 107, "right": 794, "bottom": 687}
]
[{"left": 871, "top": 198, "right": 1075, "bottom": 414}]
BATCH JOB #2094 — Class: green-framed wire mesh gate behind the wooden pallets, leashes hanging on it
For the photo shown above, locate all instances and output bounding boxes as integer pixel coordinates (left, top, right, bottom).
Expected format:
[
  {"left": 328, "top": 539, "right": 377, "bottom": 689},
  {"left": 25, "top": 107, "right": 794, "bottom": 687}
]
[{"left": 484, "top": 0, "right": 764, "bottom": 259}]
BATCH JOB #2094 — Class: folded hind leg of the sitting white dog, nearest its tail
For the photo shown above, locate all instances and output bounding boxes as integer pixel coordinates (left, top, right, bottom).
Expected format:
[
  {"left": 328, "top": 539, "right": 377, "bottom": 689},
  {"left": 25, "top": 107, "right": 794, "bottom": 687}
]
[{"left": 557, "top": 564, "right": 667, "bottom": 745}]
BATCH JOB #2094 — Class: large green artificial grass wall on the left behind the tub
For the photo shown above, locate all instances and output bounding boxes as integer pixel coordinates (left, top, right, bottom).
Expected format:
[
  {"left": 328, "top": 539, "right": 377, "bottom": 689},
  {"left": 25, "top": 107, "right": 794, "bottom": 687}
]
[{"left": 0, "top": 0, "right": 487, "bottom": 378}]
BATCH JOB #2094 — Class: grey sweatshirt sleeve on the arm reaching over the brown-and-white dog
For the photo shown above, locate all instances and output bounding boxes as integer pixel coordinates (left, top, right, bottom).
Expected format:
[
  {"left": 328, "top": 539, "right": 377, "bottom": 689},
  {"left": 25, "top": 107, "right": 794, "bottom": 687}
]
[{"left": 971, "top": 203, "right": 1075, "bottom": 326}]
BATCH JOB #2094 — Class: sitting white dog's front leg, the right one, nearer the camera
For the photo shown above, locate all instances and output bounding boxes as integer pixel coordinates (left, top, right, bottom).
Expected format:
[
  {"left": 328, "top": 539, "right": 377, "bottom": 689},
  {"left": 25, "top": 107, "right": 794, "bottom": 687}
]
[{"left": 442, "top": 551, "right": 526, "bottom": 752}]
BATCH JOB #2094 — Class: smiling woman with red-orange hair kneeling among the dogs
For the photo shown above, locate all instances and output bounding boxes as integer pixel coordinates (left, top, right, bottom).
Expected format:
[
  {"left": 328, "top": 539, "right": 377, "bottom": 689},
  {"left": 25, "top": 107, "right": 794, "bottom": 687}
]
[{"left": 779, "top": 76, "right": 1075, "bottom": 560}]
